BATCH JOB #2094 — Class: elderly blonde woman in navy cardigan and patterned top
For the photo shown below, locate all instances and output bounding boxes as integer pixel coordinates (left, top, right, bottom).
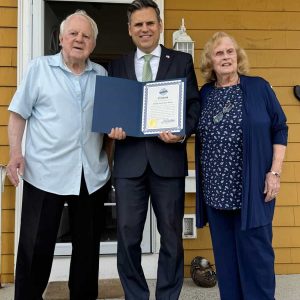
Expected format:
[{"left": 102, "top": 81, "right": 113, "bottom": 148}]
[{"left": 195, "top": 32, "right": 288, "bottom": 300}]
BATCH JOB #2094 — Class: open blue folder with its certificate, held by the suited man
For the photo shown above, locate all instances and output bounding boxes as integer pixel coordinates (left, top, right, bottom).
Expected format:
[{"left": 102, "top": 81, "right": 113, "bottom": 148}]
[{"left": 92, "top": 76, "right": 186, "bottom": 137}]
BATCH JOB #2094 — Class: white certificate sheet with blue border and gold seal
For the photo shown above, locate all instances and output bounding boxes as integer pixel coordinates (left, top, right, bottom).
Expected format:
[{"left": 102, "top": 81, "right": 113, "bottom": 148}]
[{"left": 142, "top": 79, "right": 185, "bottom": 135}]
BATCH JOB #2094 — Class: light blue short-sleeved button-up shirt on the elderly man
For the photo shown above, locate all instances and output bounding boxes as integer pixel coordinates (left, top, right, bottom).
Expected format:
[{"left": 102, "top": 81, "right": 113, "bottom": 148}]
[{"left": 8, "top": 53, "right": 110, "bottom": 195}]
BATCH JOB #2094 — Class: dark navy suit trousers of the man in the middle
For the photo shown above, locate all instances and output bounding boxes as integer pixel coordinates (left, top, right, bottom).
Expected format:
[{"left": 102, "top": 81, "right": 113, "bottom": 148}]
[{"left": 115, "top": 165, "right": 185, "bottom": 300}]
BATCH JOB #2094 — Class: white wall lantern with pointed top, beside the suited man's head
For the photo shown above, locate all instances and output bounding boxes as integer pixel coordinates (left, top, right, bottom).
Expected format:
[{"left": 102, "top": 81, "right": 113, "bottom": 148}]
[{"left": 173, "top": 19, "right": 195, "bottom": 59}]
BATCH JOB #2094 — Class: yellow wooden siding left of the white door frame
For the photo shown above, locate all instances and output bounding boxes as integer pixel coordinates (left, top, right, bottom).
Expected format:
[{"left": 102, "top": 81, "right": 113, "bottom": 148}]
[{"left": 0, "top": 0, "right": 18, "bottom": 283}]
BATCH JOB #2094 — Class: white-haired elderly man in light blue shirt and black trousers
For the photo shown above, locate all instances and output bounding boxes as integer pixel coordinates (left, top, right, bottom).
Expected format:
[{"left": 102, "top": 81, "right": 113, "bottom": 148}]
[{"left": 7, "top": 11, "right": 110, "bottom": 300}]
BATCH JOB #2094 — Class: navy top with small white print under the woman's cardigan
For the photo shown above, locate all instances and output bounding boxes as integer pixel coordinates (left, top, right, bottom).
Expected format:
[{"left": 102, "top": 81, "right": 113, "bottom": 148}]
[{"left": 198, "top": 84, "right": 243, "bottom": 210}]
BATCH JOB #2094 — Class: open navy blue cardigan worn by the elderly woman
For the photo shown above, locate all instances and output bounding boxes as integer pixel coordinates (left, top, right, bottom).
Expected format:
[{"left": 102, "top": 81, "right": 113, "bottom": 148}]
[{"left": 195, "top": 76, "right": 288, "bottom": 230}]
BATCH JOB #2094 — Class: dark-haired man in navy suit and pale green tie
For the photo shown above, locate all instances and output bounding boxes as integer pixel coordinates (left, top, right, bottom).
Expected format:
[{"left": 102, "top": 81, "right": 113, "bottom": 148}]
[{"left": 109, "top": 0, "right": 199, "bottom": 300}]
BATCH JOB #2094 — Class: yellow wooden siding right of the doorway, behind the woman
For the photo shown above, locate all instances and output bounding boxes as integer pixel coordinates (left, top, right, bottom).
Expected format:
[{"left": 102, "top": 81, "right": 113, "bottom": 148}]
[{"left": 165, "top": 0, "right": 300, "bottom": 276}]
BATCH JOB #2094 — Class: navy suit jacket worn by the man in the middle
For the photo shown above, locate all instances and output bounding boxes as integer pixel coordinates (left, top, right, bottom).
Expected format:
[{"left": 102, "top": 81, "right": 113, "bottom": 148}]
[{"left": 108, "top": 46, "right": 200, "bottom": 178}]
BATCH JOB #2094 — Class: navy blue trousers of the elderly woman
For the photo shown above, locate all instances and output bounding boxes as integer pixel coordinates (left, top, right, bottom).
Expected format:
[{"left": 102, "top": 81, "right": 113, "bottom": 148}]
[{"left": 207, "top": 206, "right": 275, "bottom": 300}]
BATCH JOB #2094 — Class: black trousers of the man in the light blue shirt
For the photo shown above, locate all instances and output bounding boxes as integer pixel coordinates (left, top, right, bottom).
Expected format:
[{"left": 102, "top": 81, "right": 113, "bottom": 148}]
[{"left": 15, "top": 176, "right": 109, "bottom": 300}]
